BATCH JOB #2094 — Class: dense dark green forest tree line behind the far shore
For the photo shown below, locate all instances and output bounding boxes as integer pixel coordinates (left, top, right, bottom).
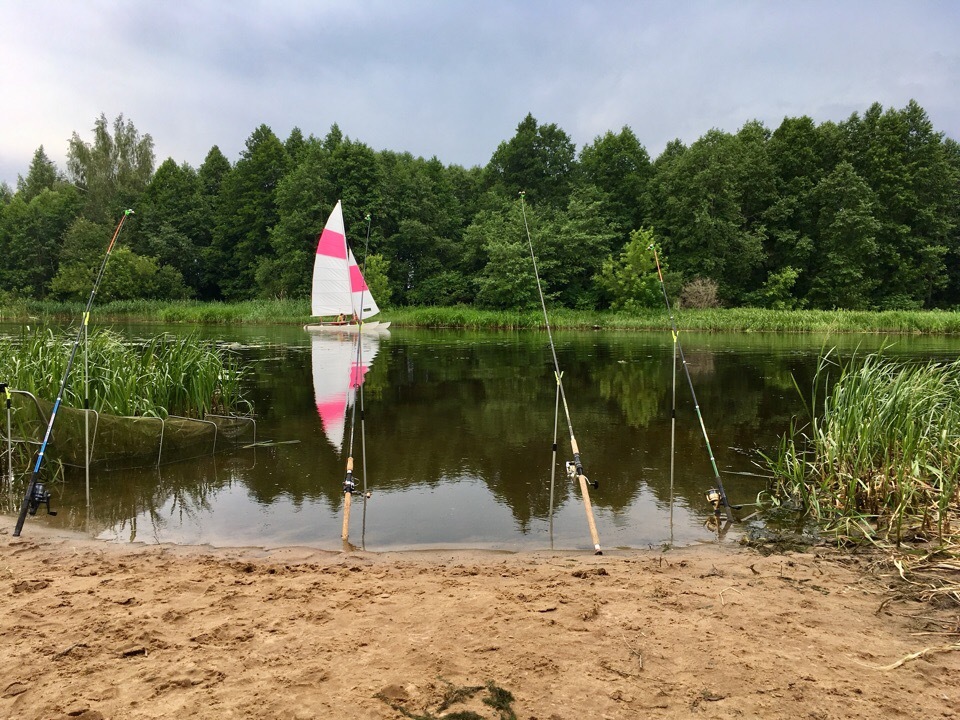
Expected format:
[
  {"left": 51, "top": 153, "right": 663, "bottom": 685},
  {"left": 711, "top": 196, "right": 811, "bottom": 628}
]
[{"left": 0, "top": 101, "right": 960, "bottom": 310}]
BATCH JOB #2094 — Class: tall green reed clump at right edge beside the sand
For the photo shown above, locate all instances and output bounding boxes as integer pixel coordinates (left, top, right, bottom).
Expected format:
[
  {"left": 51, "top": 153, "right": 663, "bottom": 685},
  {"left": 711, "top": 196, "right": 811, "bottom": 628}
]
[{"left": 766, "top": 353, "right": 960, "bottom": 545}]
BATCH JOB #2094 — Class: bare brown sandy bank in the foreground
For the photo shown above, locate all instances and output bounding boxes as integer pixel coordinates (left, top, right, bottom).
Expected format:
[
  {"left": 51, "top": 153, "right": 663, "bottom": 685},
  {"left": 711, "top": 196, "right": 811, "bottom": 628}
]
[{"left": 0, "top": 517, "right": 960, "bottom": 720}]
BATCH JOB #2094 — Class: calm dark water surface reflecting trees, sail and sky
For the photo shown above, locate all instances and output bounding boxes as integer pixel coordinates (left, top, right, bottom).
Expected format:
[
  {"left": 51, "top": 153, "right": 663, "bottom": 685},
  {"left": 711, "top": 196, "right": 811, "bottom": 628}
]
[{"left": 0, "top": 326, "right": 960, "bottom": 551}]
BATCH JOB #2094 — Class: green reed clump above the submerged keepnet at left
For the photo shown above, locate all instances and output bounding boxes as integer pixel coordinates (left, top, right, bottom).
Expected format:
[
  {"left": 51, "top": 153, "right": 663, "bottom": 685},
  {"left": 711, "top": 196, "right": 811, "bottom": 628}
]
[{"left": 0, "top": 329, "right": 246, "bottom": 418}]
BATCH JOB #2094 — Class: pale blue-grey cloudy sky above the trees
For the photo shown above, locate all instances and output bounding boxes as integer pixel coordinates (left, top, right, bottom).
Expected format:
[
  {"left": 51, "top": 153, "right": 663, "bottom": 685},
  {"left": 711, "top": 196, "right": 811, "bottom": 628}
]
[{"left": 0, "top": 0, "right": 960, "bottom": 187}]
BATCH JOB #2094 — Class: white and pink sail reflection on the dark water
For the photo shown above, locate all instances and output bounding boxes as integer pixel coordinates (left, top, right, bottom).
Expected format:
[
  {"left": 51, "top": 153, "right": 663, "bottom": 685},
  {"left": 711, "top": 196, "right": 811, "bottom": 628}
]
[{"left": 310, "top": 330, "right": 390, "bottom": 452}]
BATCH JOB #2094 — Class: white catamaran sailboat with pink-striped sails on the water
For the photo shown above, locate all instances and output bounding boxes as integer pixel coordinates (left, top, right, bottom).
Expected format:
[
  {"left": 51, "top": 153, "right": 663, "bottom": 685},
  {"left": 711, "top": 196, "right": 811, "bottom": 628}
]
[{"left": 304, "top": 200, "right": 390, "bottom": 332}]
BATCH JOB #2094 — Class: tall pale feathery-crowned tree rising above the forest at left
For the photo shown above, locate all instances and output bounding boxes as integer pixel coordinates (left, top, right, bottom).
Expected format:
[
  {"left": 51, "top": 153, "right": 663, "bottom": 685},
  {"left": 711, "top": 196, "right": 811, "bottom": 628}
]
[{"left": 67, "top": 114, "right": 154, "bottom": 222}]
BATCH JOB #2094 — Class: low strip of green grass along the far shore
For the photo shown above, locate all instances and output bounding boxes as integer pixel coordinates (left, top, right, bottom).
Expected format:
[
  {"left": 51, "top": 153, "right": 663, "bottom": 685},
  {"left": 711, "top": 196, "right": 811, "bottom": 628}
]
[{"left": 0, "top": 300, "right": 960, "bottom": 335}]
